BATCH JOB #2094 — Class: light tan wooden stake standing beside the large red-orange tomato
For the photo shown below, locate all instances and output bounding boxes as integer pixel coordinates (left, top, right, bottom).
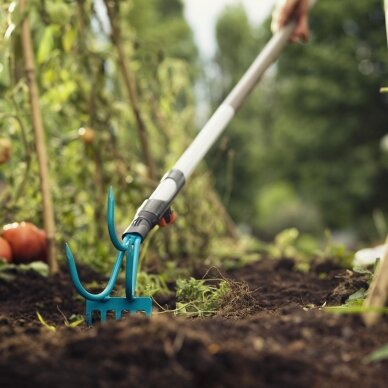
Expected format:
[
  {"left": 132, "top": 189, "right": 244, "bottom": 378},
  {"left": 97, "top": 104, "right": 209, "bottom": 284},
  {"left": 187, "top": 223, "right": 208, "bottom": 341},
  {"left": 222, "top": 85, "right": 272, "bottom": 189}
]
[{"left": 19, "top": 0, "right": 59, "bottom": 274}]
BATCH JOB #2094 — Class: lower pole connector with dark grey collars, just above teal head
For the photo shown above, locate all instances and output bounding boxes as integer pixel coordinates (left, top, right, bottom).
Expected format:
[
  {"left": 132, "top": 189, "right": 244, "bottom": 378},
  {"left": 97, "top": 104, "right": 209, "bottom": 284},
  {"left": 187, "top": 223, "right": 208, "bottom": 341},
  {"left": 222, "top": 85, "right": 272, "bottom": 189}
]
[{"left": 123, "top": 169, "right": 186, "bottom": 240}]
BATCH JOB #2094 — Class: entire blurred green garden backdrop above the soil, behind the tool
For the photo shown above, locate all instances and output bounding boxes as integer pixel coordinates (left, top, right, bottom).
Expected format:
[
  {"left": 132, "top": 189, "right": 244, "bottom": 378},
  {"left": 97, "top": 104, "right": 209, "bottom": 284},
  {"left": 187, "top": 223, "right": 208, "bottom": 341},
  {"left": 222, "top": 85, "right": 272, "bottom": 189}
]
[{"left": 0, "top": 0, "right": 388, "bottom": 265}]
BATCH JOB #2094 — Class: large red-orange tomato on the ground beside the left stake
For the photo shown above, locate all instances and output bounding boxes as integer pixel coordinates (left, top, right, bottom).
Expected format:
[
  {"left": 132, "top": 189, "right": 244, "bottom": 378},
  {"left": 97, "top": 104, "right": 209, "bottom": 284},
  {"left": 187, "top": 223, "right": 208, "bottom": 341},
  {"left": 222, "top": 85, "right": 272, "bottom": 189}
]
[{"left": 2, "top": 222, "right": 47, "bottom": 263}]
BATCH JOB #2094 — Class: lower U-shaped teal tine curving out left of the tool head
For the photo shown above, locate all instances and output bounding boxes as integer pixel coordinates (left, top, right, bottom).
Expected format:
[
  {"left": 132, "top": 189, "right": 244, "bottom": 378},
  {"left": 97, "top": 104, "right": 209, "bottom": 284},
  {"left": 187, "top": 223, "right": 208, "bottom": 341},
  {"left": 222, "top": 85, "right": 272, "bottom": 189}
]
[{"left": 65, "top": 243, "right": 125, "bottom": 301}]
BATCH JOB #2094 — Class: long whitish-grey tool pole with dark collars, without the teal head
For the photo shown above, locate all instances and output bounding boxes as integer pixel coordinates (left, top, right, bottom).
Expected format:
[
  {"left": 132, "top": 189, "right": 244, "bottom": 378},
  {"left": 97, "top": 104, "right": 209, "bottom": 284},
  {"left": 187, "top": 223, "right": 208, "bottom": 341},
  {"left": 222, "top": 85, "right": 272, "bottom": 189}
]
[{"left": 123, "top": 0, "right": 316, "bottom": 239}]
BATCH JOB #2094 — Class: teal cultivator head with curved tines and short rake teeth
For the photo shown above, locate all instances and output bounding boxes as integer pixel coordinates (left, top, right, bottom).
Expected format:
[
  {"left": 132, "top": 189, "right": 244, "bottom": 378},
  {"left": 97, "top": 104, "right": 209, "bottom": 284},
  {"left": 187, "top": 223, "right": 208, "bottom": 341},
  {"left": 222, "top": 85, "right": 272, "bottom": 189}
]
[{"left": 66, "top": 189, "right": 152, "bottom": 325}]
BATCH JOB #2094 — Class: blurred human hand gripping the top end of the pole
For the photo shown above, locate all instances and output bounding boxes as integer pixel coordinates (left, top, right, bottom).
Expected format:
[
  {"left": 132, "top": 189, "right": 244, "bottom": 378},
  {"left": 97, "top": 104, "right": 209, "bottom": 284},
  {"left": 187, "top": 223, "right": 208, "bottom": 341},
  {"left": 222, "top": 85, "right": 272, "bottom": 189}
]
[{"left": 271, "top": 0, "right": 309, "bottom": 42}]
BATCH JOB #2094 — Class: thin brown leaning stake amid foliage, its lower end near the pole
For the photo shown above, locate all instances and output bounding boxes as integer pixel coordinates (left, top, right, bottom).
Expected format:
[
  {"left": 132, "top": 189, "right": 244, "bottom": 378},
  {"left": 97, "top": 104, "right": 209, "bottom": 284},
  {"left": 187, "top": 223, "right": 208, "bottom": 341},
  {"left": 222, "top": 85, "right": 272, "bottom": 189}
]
[{"left": 104, "top": 0, "right": 156, "bottom": 180}]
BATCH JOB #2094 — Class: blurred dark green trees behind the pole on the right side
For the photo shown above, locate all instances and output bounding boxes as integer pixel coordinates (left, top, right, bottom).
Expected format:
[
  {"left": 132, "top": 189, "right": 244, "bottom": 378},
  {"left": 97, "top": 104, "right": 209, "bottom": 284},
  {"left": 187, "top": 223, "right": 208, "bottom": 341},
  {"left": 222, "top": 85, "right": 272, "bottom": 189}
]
[{"left": 210, "top": 0, "right": 388, "bottom": 240}]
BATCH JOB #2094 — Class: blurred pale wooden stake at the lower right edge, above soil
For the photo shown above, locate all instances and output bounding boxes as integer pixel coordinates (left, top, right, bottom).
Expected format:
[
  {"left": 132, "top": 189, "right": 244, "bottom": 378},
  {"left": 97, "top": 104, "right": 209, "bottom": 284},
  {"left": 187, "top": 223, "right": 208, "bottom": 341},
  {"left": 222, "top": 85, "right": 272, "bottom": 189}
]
[{"left": 362, "top": 236, "right": 388, "bottom": 327}]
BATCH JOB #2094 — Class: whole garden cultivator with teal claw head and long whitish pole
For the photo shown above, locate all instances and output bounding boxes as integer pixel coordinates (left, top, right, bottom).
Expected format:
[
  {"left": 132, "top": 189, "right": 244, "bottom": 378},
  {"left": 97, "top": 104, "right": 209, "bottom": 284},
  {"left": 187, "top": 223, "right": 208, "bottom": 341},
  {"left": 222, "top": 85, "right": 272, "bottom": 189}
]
[{"left": 66, "top": 3, "right": 316, "bottom": 325}]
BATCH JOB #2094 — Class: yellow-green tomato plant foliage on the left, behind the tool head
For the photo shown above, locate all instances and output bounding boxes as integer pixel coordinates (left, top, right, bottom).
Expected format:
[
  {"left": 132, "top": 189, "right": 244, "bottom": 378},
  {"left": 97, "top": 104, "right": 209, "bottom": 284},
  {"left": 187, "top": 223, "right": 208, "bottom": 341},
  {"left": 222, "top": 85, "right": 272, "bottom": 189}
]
[{"left": 0, "top": 0, "right": 229, "bottom": 274}]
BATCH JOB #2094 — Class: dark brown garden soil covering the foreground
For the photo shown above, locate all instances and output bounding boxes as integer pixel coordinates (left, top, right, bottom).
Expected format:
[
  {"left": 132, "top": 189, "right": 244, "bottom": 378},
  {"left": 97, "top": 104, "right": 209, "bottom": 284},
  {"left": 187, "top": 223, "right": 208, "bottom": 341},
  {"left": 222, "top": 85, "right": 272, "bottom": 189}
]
[{"left": 0, "top": 260, "right": 388, "bottom": 387}]
